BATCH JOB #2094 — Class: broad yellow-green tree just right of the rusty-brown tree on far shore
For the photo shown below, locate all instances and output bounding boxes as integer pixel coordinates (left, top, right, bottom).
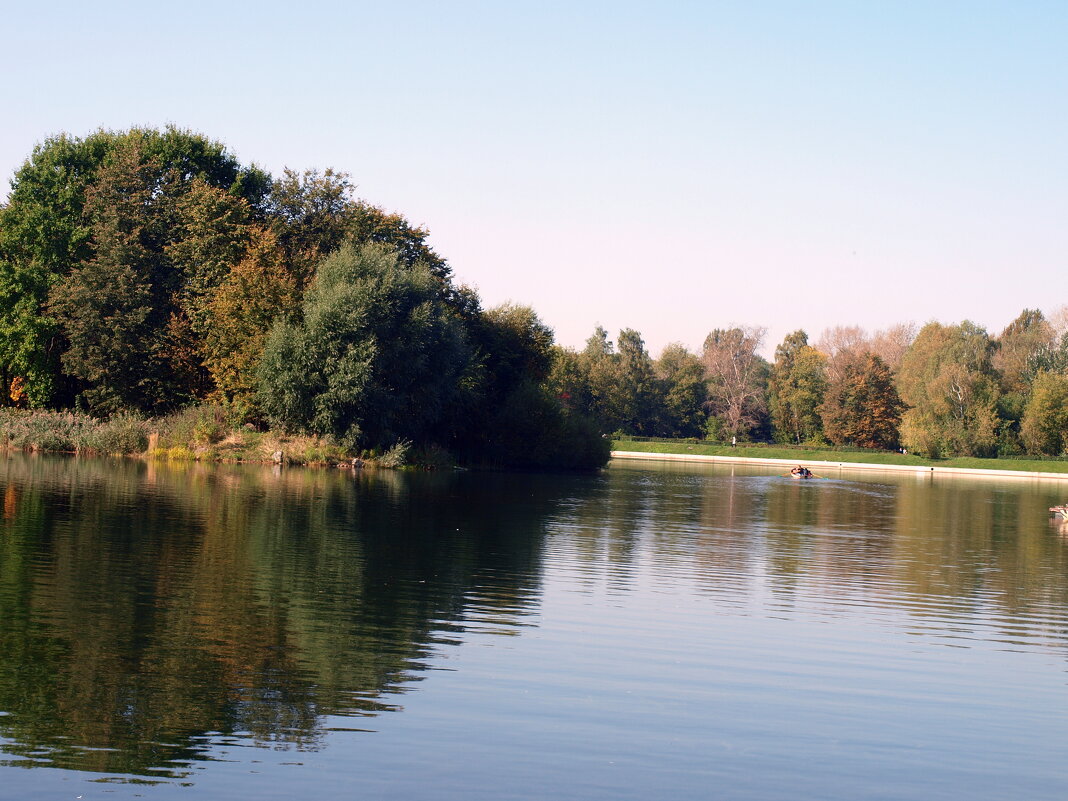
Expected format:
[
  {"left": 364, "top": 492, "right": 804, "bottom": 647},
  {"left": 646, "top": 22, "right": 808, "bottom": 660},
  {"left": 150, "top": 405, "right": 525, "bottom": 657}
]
[{"left": 897, "top": 320, "right": 1000, "bottom": 456}]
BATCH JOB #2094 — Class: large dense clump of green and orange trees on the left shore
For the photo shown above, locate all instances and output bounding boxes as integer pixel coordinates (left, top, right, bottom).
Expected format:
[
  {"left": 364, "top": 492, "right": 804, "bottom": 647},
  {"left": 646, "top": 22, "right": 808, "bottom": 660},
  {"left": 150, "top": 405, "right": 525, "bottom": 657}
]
[{"left": 0, "top": 128, "right": 607, "bottom": 466}]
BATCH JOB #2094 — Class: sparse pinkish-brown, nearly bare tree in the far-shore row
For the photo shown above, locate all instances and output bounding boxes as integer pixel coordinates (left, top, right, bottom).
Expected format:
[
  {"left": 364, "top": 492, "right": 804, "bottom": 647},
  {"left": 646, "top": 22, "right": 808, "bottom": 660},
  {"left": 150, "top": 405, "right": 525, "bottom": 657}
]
[{"left": 701, "top": 327, "right": 767, "bottom": 437}]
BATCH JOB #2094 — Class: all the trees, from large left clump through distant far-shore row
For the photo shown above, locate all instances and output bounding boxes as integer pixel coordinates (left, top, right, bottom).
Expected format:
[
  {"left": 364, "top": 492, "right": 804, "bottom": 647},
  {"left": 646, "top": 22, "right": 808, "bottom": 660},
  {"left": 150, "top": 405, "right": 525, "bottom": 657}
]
[{"left": 0, "top": 127, "right": 1068, "bottom": 467}]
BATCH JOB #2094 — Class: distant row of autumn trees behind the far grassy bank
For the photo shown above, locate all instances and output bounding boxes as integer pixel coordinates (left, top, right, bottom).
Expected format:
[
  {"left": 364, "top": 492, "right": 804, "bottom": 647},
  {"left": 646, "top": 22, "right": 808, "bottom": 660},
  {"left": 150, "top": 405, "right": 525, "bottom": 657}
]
[{"left": 550, "top": 310, "right": 1068, "bottom": 456}]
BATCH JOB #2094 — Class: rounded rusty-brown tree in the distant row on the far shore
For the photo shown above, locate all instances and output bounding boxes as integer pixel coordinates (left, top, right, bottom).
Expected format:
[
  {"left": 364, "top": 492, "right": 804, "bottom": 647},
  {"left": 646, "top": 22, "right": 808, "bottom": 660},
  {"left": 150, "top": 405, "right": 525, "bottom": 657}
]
[{"left": 820, "top": 354, "right": 905, "bottom": 450}]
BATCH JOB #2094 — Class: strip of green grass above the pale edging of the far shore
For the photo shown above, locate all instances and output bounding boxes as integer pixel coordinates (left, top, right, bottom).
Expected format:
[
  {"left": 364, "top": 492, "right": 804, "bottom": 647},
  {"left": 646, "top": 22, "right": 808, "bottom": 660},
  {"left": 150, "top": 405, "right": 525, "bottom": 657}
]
[{"left": 612, "top": 439, "right": 1068, "bottom": 473}]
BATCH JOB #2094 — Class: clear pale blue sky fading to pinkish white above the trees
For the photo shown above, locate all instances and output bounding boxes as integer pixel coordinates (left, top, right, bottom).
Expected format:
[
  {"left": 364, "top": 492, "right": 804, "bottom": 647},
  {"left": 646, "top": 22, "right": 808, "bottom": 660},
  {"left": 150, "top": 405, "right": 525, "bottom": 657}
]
[{"left": 0, "top": 0, "right": 1068, "bottom": 356}]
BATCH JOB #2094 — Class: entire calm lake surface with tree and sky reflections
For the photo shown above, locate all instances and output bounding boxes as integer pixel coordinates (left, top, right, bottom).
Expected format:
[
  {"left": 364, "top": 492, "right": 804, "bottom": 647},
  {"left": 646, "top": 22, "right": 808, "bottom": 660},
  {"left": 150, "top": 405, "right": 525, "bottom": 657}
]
[{"left": 0, "top": 456, "right": 1068, "bottom": 801}]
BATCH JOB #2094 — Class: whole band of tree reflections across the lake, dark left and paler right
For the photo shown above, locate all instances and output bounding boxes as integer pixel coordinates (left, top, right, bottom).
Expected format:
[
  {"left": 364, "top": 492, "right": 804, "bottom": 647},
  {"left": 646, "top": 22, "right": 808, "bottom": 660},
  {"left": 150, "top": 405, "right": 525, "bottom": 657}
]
[{"left": 0, "top": 457, "right": 1068, "bottom": 775}]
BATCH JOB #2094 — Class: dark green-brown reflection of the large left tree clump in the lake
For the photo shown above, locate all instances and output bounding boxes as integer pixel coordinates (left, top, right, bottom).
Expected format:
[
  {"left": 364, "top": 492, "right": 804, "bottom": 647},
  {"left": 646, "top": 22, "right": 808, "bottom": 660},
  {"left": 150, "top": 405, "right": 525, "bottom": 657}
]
[{"left": 0, "top": 457, "right": 559, "bottom": 774}]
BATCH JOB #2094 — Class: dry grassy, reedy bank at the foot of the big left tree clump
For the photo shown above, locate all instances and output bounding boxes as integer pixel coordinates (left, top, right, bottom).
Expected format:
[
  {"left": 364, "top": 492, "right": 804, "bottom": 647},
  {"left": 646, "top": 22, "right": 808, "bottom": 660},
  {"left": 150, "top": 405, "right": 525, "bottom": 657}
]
[{"left": 0, "top": 406, "right": 437, "bottom": 467}]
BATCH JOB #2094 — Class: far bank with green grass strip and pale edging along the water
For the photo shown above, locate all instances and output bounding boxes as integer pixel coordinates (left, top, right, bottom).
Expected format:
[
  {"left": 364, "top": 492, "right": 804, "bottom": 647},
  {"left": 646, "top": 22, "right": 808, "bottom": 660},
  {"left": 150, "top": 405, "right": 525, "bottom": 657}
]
[{"left": 612, "top": 440, "right": 1068, "bottom": 481}]
